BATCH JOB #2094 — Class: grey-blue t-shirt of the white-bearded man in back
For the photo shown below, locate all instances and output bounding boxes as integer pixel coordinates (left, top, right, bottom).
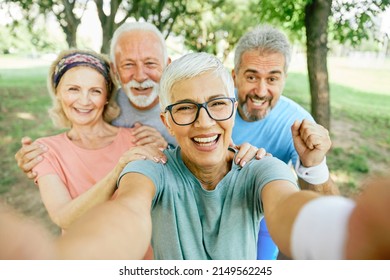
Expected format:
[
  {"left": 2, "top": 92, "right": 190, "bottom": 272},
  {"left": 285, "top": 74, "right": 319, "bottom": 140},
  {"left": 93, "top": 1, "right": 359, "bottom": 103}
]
[{"left": 111, "top": 89, "right": 176, "bottom": 146}]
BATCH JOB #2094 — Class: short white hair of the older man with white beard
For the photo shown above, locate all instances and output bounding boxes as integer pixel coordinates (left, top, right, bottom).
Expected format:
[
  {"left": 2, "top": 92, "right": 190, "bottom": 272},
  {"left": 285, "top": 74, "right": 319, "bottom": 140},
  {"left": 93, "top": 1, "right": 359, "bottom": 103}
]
[{"left": 110, "top": 21, "right": 168, "bottom": 66}]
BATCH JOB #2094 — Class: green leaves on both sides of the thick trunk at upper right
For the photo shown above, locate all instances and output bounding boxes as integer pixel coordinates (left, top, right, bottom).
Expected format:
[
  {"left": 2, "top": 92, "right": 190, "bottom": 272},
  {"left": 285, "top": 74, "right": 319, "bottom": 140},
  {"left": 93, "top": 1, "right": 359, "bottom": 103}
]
[{"left": 252, "top": 0, "right": 390, "bottom": 46}]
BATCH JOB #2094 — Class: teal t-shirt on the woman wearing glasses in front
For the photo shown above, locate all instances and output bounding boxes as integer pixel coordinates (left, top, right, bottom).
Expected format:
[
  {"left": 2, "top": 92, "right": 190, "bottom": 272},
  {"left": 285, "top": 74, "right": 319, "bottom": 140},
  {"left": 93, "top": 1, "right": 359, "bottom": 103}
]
[{"left": 118, "top": 147, "right": 296, "bottom": 260}]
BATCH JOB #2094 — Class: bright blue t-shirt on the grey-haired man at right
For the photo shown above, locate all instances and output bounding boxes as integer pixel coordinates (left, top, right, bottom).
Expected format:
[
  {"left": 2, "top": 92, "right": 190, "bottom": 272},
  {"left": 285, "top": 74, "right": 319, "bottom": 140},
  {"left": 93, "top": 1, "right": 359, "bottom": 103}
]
[{"left": 232, "top": 96, "right": 314, "bottom": 166}]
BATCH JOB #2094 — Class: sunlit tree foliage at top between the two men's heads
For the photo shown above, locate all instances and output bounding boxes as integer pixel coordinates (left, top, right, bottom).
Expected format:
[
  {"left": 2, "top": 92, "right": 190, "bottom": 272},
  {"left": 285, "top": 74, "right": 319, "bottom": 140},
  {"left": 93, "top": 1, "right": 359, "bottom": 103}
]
[{"left": 173, "top": 0, "right": 259, "bottom": 61}]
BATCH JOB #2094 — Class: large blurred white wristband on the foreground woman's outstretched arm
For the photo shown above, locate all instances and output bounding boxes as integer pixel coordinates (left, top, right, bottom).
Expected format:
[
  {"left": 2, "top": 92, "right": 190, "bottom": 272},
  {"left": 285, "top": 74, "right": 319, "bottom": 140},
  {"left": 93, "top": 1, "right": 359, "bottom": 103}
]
[{"left": 291, "top": 196, "right": 355, "bottom": 260}]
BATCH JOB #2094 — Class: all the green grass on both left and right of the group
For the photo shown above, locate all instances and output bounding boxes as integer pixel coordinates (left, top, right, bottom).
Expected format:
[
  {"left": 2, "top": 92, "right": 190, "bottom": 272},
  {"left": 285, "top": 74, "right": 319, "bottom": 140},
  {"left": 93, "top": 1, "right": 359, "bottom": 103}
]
[{"left": 0, "top": 55, "right": 390, "bottom": 228}]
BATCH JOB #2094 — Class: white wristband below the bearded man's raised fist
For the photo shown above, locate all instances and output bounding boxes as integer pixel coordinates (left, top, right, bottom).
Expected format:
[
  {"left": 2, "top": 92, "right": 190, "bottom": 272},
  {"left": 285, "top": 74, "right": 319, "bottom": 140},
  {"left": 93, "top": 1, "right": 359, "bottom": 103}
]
[{"left": 295, "top": 157, "right": 329, "bottom": 185}]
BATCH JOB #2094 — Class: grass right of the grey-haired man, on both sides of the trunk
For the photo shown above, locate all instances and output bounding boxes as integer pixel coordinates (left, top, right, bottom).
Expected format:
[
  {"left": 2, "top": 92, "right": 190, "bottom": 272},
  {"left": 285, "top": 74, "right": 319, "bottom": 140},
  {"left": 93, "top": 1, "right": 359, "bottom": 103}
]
[{"left": 284, "top": 67, "right": 390, "bottom": 194}]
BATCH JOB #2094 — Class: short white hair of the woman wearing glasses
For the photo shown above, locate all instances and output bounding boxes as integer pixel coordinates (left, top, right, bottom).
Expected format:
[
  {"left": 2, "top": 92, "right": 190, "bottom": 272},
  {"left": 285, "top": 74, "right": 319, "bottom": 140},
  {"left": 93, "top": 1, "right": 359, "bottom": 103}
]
[{"left": 159, "top": 52, "right": 235, "bottom": 112}]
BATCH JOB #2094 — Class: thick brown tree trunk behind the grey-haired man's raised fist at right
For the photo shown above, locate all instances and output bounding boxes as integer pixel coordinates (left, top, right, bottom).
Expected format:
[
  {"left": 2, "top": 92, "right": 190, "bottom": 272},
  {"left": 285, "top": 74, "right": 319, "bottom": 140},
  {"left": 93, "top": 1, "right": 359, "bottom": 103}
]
[{"left": 305, "top": 0, "right": 332, "bottom": 130}]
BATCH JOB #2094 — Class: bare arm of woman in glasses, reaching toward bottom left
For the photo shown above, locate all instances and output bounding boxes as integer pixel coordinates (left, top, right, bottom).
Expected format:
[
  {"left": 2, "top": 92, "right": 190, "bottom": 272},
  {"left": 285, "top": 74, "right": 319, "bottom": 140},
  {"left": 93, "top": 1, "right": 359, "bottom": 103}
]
[{"left": 57, "top": 173, "right": 155, "bottom": 259}]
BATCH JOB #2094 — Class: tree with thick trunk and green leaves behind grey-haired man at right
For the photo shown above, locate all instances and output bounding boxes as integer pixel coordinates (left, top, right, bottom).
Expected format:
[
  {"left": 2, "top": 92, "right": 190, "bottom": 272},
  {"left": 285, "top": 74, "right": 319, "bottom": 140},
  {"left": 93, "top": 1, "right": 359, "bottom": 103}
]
[{"left": 252, "top": 0, "right": 390, "bottom": 130}]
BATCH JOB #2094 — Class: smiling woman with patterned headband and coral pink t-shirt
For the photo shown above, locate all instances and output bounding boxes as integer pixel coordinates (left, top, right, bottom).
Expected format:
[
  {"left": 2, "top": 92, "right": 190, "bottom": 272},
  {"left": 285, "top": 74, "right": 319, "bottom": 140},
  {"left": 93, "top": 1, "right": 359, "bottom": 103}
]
[{"left": 30, "top": 50, "right": 165, "bottom": 249}]
